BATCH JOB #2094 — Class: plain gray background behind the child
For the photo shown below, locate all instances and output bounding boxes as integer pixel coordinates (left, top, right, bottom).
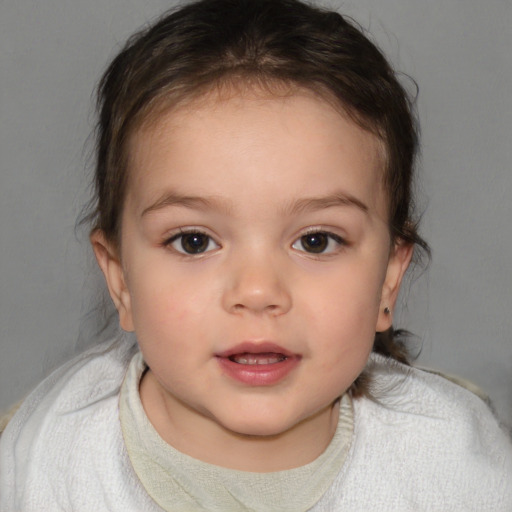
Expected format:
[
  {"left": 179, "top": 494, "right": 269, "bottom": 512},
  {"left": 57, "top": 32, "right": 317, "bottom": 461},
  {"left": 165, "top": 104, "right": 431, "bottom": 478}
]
[{"left": 0, "top": 0, "right": 512, "bottom": 424}]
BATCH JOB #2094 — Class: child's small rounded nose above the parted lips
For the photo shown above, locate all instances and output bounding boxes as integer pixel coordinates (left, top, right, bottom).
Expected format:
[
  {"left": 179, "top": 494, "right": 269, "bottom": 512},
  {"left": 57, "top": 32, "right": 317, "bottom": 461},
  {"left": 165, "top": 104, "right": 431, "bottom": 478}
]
[{"left": 223, "top": 257, "right": 292, "bottom": 316}]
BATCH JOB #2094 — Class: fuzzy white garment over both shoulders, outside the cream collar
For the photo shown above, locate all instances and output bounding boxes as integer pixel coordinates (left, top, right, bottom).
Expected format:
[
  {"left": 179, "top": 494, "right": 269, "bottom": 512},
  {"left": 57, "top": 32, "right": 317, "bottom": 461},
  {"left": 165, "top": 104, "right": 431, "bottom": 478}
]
[{"left": 0, "top": 334, "right": 512, "bottom": 512}]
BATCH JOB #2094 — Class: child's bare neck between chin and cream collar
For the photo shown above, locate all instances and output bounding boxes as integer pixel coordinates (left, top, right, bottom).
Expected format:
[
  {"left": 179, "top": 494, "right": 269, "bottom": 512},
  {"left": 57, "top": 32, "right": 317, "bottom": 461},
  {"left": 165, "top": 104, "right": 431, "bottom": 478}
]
[{"left": 140, "top": 371, "right": 339, "bottom": 473}]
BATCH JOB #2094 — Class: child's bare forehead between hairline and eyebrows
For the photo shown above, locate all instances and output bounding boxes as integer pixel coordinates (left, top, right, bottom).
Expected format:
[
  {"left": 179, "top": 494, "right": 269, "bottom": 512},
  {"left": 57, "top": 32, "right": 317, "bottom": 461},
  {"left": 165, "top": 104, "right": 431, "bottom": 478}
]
[{"left": 128, "top": 90, "right": 387, "bottom": 214}]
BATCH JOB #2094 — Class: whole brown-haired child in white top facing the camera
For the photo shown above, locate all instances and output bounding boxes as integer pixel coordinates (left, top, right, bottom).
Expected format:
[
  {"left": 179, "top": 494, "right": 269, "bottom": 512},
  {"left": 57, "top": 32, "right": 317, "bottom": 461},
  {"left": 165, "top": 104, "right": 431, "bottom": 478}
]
[{"left": 0, "top": 0, "right": 512, "bottom": 512}]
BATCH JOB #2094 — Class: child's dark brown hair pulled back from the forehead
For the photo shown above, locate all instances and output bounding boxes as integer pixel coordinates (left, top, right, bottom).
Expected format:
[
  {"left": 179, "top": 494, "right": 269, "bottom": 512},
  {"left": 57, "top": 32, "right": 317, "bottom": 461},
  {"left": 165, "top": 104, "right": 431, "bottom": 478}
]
[{"left": 92, "top": 0, "right": 428, "bottom": 388}]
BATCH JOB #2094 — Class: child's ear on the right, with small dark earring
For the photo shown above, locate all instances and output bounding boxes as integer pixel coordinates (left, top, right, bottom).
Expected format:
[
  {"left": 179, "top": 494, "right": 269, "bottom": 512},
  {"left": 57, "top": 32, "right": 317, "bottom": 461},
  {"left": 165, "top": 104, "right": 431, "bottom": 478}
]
[{"left": 375, "top": 240, "right": 414, "bottom": 332}]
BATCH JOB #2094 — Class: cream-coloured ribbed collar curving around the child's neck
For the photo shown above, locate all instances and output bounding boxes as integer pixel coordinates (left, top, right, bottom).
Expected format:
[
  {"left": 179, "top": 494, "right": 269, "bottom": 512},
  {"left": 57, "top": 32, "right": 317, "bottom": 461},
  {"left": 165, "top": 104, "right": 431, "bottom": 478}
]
[{"left": 119, "top": 353, "right": 354, "bottom": 512}]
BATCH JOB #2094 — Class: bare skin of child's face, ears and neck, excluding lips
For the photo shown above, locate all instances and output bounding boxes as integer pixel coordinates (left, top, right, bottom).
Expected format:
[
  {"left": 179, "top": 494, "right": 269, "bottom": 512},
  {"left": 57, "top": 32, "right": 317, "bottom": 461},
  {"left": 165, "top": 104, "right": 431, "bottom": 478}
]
[{"left": 92, "top": 92, "right": 412, "bottom": 471}]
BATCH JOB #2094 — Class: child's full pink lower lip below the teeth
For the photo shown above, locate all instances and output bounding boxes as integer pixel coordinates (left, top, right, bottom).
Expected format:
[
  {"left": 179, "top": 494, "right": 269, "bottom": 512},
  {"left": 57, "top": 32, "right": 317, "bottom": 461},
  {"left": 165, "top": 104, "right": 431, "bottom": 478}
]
[{"left": 217, "top": 356, "right": 300, "bottom": 386}]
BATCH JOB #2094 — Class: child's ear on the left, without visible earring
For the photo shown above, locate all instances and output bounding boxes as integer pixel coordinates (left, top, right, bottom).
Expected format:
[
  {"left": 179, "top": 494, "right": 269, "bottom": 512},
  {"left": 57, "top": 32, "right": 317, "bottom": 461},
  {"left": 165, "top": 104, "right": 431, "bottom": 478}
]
[{"left": 91, "top": 229, "right": 133, "bottom": 331}]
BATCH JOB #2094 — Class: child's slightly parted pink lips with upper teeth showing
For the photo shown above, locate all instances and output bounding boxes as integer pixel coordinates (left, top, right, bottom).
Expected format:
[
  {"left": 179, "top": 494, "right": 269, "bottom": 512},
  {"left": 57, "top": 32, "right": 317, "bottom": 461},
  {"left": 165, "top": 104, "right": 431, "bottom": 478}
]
[{"left": 216, "top": 342, "right": 301, "bottom": 386}]
